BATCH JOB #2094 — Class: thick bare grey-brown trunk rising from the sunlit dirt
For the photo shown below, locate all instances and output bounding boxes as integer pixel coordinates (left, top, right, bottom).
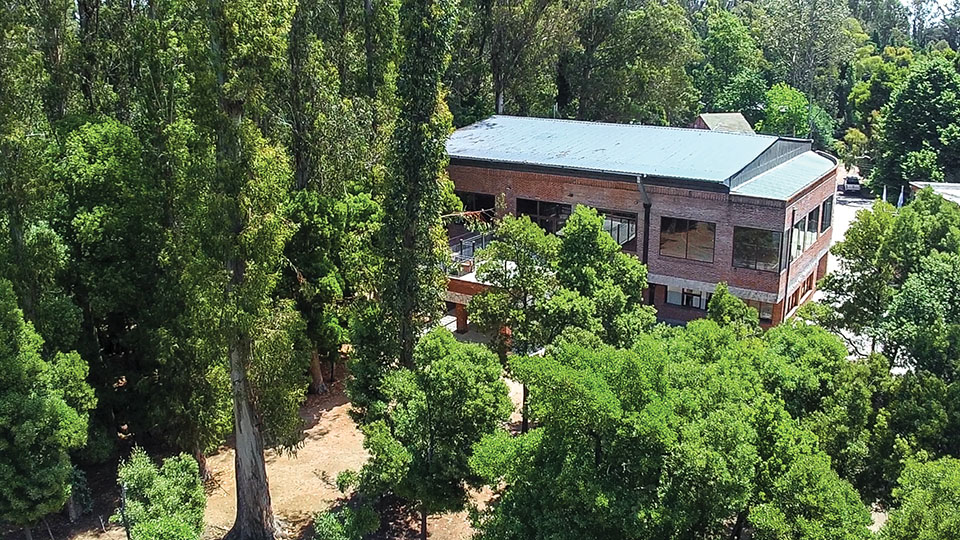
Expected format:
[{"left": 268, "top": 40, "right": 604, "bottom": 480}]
[{"left": 224, "top": 335, "right": 277, "bottom": 540}]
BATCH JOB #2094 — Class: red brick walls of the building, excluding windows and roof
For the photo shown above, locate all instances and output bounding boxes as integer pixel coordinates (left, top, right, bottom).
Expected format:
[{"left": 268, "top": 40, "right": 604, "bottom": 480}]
[{"left": 449, "top": 158, "right": 836, "bottom": 322}]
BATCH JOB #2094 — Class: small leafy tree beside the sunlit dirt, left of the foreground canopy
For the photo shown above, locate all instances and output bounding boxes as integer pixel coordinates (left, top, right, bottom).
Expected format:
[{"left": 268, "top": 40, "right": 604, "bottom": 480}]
[{"left": 360, "top": 329, "right": 512, "bottom": 513}]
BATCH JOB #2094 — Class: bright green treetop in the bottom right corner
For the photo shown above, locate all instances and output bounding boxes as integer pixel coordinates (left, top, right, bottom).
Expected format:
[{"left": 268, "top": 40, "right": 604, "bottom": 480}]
[{"left": 880, "top": 458, "right": 960, "bottom": 540}]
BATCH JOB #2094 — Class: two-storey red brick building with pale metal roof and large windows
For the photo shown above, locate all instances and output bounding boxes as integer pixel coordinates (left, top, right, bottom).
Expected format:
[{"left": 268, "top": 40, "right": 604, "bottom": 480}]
[{"left": 447, "top": 116, "right": 837, "bottom": 328}]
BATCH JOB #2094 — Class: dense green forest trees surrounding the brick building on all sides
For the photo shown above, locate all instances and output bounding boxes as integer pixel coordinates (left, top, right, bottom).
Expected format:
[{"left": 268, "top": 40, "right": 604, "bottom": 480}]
[{"left": 0, "top": 0, "right": 960, "bottom": 539}]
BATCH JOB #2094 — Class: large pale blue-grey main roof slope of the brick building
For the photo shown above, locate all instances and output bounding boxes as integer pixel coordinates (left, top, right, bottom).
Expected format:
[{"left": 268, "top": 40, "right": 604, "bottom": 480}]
[{"left": 447, "top": 116, "right": 778, "bottom": 183}]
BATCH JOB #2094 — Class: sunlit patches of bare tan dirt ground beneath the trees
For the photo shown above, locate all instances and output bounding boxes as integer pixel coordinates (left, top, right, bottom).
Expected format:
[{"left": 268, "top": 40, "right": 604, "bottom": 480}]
[{"left": 0, "top": 374, "right": 521, "bottom": 540}]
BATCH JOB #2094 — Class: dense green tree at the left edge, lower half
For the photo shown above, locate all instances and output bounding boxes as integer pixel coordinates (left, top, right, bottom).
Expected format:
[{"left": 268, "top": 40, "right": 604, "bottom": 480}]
[{"left": 0, "top": 279, "right": 96, "bottom": 526}]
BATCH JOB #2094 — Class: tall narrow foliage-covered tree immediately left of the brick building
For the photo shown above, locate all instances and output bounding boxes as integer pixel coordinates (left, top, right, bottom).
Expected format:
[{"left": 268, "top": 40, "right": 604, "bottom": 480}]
[{"left": 368, "top": 0, "right": 456, "bottom": 376}]
